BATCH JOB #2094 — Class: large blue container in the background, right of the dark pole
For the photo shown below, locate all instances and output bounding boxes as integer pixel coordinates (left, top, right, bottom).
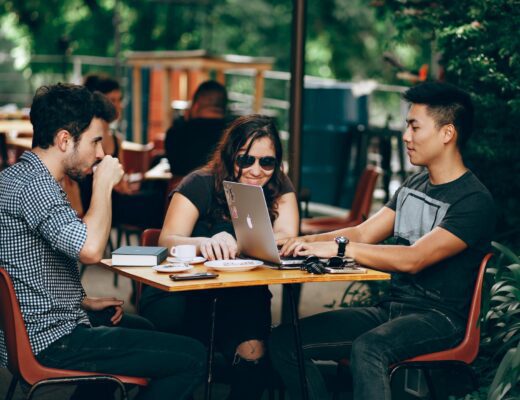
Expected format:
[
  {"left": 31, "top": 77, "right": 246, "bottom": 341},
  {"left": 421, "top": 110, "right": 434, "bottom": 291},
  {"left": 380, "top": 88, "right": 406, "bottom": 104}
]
[{"left": 301, "top": 83, "right": 368, "bottom": 208}]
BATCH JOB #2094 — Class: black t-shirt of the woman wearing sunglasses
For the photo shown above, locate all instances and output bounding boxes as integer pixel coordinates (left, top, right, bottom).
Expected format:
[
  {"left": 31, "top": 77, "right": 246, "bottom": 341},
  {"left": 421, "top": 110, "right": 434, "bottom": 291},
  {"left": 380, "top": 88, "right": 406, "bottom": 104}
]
[{"left": 174, "top": 169, "right": 294, "bottom": 237}]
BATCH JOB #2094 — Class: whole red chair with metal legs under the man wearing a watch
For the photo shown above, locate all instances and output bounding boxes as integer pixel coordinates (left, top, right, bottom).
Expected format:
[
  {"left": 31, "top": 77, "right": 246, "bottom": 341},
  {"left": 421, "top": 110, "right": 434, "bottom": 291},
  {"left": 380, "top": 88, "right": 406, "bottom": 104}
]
[{"left": 338, "top": 253, "right": 493, "bottom": 400}]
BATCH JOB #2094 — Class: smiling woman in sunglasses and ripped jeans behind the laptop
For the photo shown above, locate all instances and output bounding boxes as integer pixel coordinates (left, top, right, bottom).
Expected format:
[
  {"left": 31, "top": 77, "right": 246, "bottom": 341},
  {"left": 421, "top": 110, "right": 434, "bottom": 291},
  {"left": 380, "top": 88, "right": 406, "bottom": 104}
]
[{"left": 140, "top": 115, "right": 298, "bottom": 399}]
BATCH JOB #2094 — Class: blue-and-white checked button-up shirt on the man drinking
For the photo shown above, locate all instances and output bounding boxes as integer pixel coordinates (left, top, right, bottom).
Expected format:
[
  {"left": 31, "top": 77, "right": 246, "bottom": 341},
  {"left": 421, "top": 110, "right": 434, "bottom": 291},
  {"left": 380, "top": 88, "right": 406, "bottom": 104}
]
[{"left": 0, "top": 152, "right": 90, "bottom": 366}]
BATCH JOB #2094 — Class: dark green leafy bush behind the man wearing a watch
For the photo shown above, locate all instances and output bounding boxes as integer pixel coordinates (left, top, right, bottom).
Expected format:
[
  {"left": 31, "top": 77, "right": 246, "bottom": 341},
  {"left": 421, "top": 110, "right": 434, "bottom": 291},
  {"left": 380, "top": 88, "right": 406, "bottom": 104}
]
[{"left": 380, "top": 0, "right": 520, "bottom": 245}]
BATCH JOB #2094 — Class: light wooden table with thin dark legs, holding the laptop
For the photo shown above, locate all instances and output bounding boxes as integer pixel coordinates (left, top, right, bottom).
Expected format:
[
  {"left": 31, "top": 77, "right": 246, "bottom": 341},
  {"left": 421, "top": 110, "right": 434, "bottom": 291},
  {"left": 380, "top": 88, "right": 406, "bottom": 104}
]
[{"left": 100, "top": 259, "right": 390, "bottom": 399}]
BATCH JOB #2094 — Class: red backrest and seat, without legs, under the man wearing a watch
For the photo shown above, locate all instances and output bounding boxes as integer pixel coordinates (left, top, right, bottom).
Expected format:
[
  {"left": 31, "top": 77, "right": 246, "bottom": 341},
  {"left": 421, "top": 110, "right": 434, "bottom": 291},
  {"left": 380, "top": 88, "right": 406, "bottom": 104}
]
[{"left": 406, "top": 253, "right": 493, "bottom": 364}]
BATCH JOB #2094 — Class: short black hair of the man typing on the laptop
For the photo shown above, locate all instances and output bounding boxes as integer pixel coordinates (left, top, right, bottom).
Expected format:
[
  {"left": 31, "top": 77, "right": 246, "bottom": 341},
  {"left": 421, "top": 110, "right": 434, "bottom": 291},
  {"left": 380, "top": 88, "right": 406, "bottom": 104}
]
[{"left": 403, "top": 82, "right": 474, "bottom": 149}]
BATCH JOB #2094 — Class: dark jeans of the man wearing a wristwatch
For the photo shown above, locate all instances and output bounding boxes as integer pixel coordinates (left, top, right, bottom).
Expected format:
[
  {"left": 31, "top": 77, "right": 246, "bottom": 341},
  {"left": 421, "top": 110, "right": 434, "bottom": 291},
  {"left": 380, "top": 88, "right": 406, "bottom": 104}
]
[{"left": 270, "top": 303, "right": 465, "bottom": 400}]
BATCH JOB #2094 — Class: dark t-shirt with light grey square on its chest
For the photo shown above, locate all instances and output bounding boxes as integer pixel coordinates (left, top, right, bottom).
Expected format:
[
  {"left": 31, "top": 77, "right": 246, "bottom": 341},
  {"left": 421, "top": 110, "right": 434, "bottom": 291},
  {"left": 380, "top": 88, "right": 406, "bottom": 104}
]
[{"left": 386, "top": 171, "right": 495, "bottom": 319}]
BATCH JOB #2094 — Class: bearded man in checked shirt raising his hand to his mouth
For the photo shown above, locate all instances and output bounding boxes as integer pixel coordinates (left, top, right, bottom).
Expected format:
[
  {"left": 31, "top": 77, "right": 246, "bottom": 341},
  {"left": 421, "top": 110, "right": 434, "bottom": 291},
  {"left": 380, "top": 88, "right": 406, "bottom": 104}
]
[{"left": 0, "top": 84, "right": 205, "bottom": 399}]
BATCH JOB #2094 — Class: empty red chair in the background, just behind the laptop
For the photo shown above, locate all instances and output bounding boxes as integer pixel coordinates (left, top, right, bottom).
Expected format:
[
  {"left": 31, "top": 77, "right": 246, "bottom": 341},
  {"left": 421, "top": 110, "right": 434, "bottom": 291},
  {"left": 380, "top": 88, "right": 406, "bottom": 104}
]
[{"left": 301, "top": 165, "right": 381, "bottom": 235}]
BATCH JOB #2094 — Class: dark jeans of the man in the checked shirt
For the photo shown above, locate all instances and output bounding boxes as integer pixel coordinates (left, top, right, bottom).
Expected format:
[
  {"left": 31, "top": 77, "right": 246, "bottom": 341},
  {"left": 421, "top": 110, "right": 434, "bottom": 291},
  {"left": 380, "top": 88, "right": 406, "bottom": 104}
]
[{"left": 36, "top": 325, "right": 206, "bottom": 400}]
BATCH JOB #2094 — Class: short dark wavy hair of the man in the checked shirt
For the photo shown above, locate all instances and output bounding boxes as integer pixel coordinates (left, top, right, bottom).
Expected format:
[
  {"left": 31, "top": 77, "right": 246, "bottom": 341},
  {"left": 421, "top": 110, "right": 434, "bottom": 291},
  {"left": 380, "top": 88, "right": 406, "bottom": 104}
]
[{"left": 30, "top": 83, "right": 95, "bottom": 149}]
